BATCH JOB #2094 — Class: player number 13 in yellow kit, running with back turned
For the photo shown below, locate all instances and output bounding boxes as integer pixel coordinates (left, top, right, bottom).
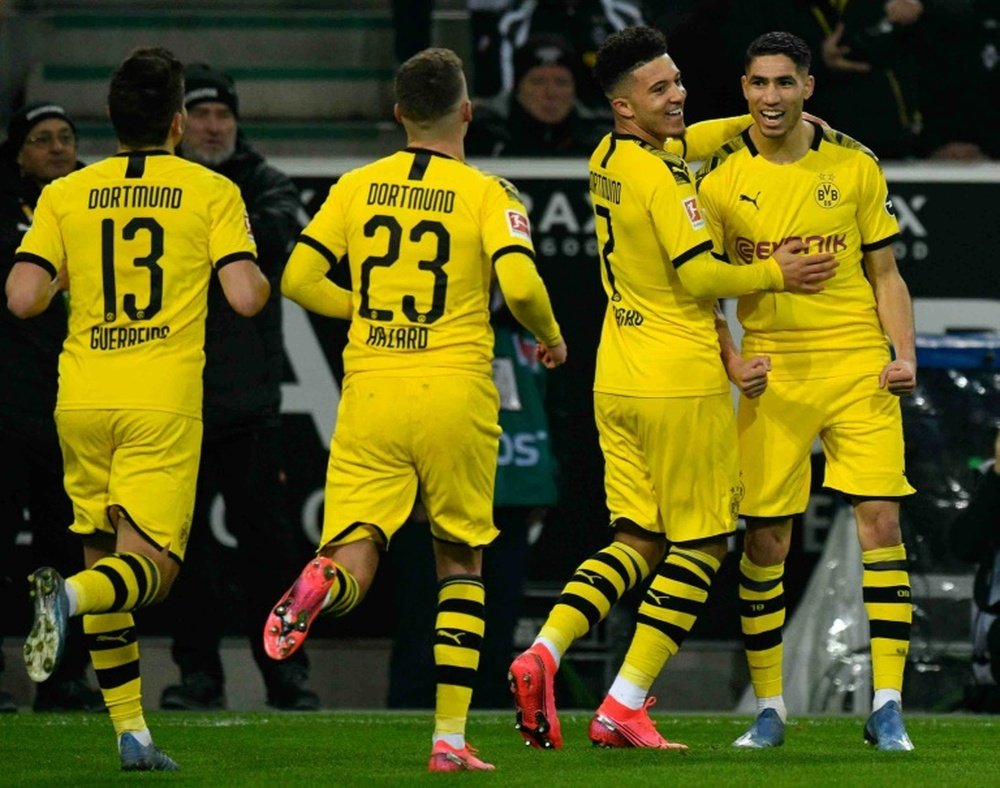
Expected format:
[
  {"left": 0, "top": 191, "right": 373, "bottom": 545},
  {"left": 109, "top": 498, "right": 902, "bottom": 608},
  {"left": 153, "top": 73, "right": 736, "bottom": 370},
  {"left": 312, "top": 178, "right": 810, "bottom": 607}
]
[{"left": 6, "top": 48, "right": 270, "bottom": 770}]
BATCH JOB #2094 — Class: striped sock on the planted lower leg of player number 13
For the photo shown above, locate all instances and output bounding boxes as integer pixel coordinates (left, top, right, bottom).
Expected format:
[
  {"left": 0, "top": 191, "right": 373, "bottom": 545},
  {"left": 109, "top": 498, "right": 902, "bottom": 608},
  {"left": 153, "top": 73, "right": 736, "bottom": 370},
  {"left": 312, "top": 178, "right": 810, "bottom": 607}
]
[{"left": 83, "top": 613, "right": 146, "bottom": 735}]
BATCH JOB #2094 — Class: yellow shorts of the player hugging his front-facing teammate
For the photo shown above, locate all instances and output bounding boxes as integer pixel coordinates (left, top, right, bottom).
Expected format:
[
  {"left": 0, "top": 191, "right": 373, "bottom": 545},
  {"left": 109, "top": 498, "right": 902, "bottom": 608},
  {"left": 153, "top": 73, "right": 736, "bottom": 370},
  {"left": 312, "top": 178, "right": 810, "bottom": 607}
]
[{"left": 594, "top": 392, "right": 742, "bottom": 542}]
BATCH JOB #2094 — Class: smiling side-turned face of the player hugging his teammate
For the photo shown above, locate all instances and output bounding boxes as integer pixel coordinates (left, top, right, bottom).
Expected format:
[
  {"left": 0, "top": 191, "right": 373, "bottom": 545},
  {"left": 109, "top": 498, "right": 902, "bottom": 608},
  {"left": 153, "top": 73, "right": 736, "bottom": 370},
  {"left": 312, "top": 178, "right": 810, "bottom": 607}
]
[{"left": 620, "top": 55, "right": 687, "bottom": 145}]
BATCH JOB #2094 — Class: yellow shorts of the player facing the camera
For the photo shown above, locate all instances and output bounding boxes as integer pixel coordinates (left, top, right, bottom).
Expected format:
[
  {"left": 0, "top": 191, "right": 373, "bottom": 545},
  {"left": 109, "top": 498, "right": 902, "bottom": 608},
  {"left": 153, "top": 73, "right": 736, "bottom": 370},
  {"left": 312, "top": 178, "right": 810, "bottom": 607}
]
[{"left": 737, "top": 372, "right": 914, "bottom": 517}]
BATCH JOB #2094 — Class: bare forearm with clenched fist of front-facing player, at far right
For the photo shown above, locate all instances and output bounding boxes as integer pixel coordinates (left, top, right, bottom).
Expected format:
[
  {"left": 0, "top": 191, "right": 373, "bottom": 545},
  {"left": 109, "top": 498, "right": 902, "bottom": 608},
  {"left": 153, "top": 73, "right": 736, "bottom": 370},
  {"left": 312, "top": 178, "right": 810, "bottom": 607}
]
[{"left": 864, "top": 244, "right": 917, "bottom": 395}]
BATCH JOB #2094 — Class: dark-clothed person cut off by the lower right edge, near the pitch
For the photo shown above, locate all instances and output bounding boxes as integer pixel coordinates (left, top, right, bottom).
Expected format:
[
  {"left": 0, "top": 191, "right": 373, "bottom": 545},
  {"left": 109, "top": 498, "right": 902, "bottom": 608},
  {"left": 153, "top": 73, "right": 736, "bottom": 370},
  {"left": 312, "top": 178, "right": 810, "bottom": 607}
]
[{"left": 949, "top": 432, "right": 1000, "bottom": 714}]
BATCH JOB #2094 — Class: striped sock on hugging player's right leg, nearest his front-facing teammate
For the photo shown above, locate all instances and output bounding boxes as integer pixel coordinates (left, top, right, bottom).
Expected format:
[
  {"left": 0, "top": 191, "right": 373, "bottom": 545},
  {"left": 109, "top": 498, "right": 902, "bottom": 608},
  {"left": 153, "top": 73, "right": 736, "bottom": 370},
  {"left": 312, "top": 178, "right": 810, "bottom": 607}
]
[{"left": 618, "top": 547, "right": 720, "bottom": 690}]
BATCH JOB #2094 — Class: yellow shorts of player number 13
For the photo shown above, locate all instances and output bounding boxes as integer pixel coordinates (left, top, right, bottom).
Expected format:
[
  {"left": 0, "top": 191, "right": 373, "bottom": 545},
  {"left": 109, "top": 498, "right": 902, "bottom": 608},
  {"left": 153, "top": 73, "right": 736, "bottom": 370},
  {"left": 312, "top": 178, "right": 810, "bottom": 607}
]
[{"left": 56, "top": 410, "right": 202, "bottom": 562}]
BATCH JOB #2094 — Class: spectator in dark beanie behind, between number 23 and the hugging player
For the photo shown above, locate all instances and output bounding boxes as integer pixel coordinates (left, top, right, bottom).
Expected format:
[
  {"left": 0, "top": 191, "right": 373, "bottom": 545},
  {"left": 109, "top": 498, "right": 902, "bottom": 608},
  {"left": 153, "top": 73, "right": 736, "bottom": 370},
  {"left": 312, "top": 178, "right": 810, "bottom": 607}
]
[{"left": 465, "top": 34, "right": 603, "bottom": 156}]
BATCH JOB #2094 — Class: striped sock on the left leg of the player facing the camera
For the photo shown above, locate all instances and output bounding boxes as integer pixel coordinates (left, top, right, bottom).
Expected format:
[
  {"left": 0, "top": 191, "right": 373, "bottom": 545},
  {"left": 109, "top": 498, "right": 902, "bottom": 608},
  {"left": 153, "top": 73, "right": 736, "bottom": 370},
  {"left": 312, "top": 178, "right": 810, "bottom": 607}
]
[{"left": 740, "top": 553, "right": 785, "bottom": 698}]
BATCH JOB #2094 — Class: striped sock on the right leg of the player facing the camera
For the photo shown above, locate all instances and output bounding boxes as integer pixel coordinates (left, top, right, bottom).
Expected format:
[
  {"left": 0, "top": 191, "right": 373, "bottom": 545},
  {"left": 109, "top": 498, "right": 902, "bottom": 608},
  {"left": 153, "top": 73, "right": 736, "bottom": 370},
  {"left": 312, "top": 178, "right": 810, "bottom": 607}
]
[{"left": 861, "top": 544, "right": 913, "bottom": 691}]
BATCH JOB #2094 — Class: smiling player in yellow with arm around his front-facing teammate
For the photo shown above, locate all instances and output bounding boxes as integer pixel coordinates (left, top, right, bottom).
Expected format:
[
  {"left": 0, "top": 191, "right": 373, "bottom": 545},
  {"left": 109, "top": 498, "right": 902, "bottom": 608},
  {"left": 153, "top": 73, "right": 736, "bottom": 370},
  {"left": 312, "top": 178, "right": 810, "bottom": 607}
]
[{"left": 509, "top": 27, "right": 835, "bottom": 749}]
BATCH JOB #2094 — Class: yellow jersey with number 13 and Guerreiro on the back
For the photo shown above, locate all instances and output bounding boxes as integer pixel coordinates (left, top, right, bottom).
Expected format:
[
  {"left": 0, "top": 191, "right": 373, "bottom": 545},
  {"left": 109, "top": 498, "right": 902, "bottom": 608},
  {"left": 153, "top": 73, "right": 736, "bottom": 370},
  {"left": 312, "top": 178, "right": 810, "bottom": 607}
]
[{"left": 15, "top": 151, "right": 256, "bottom": 419}]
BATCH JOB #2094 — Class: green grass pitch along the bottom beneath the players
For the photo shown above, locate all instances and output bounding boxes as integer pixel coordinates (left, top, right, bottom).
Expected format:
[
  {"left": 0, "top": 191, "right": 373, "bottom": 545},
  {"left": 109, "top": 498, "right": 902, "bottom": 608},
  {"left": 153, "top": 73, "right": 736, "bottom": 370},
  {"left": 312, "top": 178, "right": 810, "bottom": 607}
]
[{"left": 0, "top": 712, "right": 1000, "bottom": 788}]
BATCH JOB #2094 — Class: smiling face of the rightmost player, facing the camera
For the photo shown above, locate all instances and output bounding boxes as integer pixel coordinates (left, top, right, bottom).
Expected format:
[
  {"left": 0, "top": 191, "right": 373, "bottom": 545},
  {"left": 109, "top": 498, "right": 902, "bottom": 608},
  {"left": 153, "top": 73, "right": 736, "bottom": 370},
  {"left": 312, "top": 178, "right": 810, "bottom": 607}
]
[{"left": 742, "top": 55, "right": 814, "bottom": 138}]
